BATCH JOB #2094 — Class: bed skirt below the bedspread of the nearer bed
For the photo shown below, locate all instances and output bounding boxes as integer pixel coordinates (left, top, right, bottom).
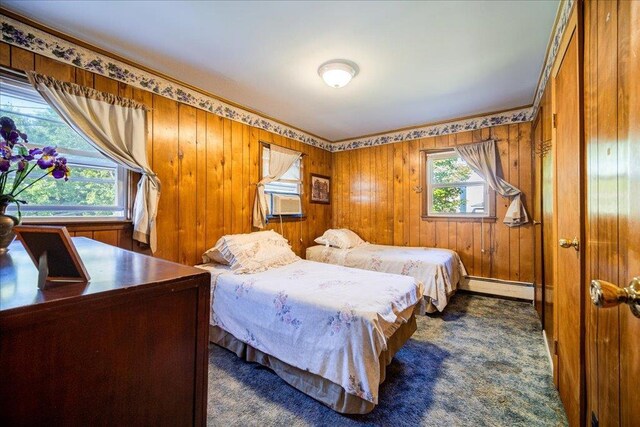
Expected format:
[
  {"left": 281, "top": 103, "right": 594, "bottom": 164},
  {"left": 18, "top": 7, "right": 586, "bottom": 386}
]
[{"left": 209, "top": 314, "right": 417, "bottom": 414}]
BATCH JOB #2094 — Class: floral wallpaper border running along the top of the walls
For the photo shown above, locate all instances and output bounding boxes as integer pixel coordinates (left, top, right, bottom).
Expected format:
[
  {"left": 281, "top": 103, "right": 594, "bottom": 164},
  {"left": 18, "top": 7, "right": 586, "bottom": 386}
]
[{"left": 0, "top": 7, "right": 574, "bottom": 152}]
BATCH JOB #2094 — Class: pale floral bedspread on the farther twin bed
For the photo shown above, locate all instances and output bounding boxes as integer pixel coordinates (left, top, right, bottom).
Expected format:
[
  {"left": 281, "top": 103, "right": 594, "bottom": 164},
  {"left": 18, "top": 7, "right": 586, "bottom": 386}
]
[{"left": 307, "top": 243, "right": 467, "bottom": 311}]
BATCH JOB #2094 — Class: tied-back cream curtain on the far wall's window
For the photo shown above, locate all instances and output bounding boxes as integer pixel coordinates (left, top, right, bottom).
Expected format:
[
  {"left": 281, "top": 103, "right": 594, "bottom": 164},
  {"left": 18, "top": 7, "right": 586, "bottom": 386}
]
[{"left": 454, "top": 140, "right": 529, "bottom": 227}]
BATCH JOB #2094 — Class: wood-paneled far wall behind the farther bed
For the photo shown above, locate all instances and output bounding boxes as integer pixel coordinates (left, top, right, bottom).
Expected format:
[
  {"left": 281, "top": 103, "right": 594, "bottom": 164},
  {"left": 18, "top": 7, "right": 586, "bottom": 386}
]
[{"left": 332, "top": 123, "right": 533, "bottom": 282}]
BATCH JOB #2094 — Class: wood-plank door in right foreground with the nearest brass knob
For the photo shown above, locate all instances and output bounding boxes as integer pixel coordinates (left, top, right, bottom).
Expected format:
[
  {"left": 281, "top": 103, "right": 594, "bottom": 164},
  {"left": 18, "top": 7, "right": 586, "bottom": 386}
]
[{"left": 585, "top": 1, "right": 640, "bottom": 426}]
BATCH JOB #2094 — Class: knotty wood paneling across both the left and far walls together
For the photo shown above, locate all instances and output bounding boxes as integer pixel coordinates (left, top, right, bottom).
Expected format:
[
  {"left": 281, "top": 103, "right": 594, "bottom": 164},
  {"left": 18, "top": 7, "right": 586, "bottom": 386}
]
[{"left": 0, "top": 39, "right": 533, "bottom": 282}]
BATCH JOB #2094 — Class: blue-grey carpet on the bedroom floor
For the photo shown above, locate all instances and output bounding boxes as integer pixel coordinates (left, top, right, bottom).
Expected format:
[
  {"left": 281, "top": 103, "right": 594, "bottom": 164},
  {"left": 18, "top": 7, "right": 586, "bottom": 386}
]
[{"left": 208, "top": 294, "right": 567, "bottom": 426}]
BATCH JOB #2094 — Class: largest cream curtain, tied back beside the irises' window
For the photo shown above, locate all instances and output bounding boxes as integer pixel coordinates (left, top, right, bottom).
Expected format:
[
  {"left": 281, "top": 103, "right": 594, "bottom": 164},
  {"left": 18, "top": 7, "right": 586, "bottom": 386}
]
[{"left": 27, "top": 72, "right": 160, "bottom": 252}]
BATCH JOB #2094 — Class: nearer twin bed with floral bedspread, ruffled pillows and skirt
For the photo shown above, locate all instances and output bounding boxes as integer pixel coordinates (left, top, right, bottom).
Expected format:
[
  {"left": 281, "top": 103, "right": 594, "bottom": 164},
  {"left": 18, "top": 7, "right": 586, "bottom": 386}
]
[{"left": 198, "top": 232, "right": 424, "bottom": 414}]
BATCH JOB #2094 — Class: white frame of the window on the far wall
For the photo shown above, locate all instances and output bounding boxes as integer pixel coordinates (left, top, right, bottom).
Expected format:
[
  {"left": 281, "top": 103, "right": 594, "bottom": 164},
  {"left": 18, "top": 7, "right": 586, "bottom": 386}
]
[{"left": 423, "top": 150, "right": 495, "bottom": 218}]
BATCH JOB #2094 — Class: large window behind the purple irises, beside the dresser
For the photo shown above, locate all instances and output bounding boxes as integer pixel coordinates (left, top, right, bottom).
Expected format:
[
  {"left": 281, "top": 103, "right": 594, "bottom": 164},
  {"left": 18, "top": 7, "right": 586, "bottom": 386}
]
[{"left": 0, "top": 76, "right": 128, "bottom": 219}]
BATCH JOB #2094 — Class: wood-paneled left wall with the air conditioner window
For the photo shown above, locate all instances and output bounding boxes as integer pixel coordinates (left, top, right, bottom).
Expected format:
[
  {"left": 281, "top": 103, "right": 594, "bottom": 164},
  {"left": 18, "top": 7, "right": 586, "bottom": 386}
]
[{"left": 0, "top": 43, "right": 331, "bottom": 264}]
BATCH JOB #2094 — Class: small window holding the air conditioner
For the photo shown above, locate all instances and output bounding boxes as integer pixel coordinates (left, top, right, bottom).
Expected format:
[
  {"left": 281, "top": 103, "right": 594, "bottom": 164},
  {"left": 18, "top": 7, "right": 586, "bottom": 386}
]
[{"left": 262, "top": 143, "right": 303, "bottom": 216}]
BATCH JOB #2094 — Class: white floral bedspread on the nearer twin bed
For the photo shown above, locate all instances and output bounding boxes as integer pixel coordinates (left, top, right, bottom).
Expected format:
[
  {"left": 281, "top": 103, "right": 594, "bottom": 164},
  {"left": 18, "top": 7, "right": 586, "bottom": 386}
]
[{"left": 198, "top": 260, "right": 423, "bottom": 404}]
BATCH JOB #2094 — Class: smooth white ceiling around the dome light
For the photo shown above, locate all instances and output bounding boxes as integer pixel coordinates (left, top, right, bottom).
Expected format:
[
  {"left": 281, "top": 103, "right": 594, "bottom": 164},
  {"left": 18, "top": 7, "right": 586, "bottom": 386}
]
[{"left": 3, "top": 0, "right": 558, "bottom": 140}]
